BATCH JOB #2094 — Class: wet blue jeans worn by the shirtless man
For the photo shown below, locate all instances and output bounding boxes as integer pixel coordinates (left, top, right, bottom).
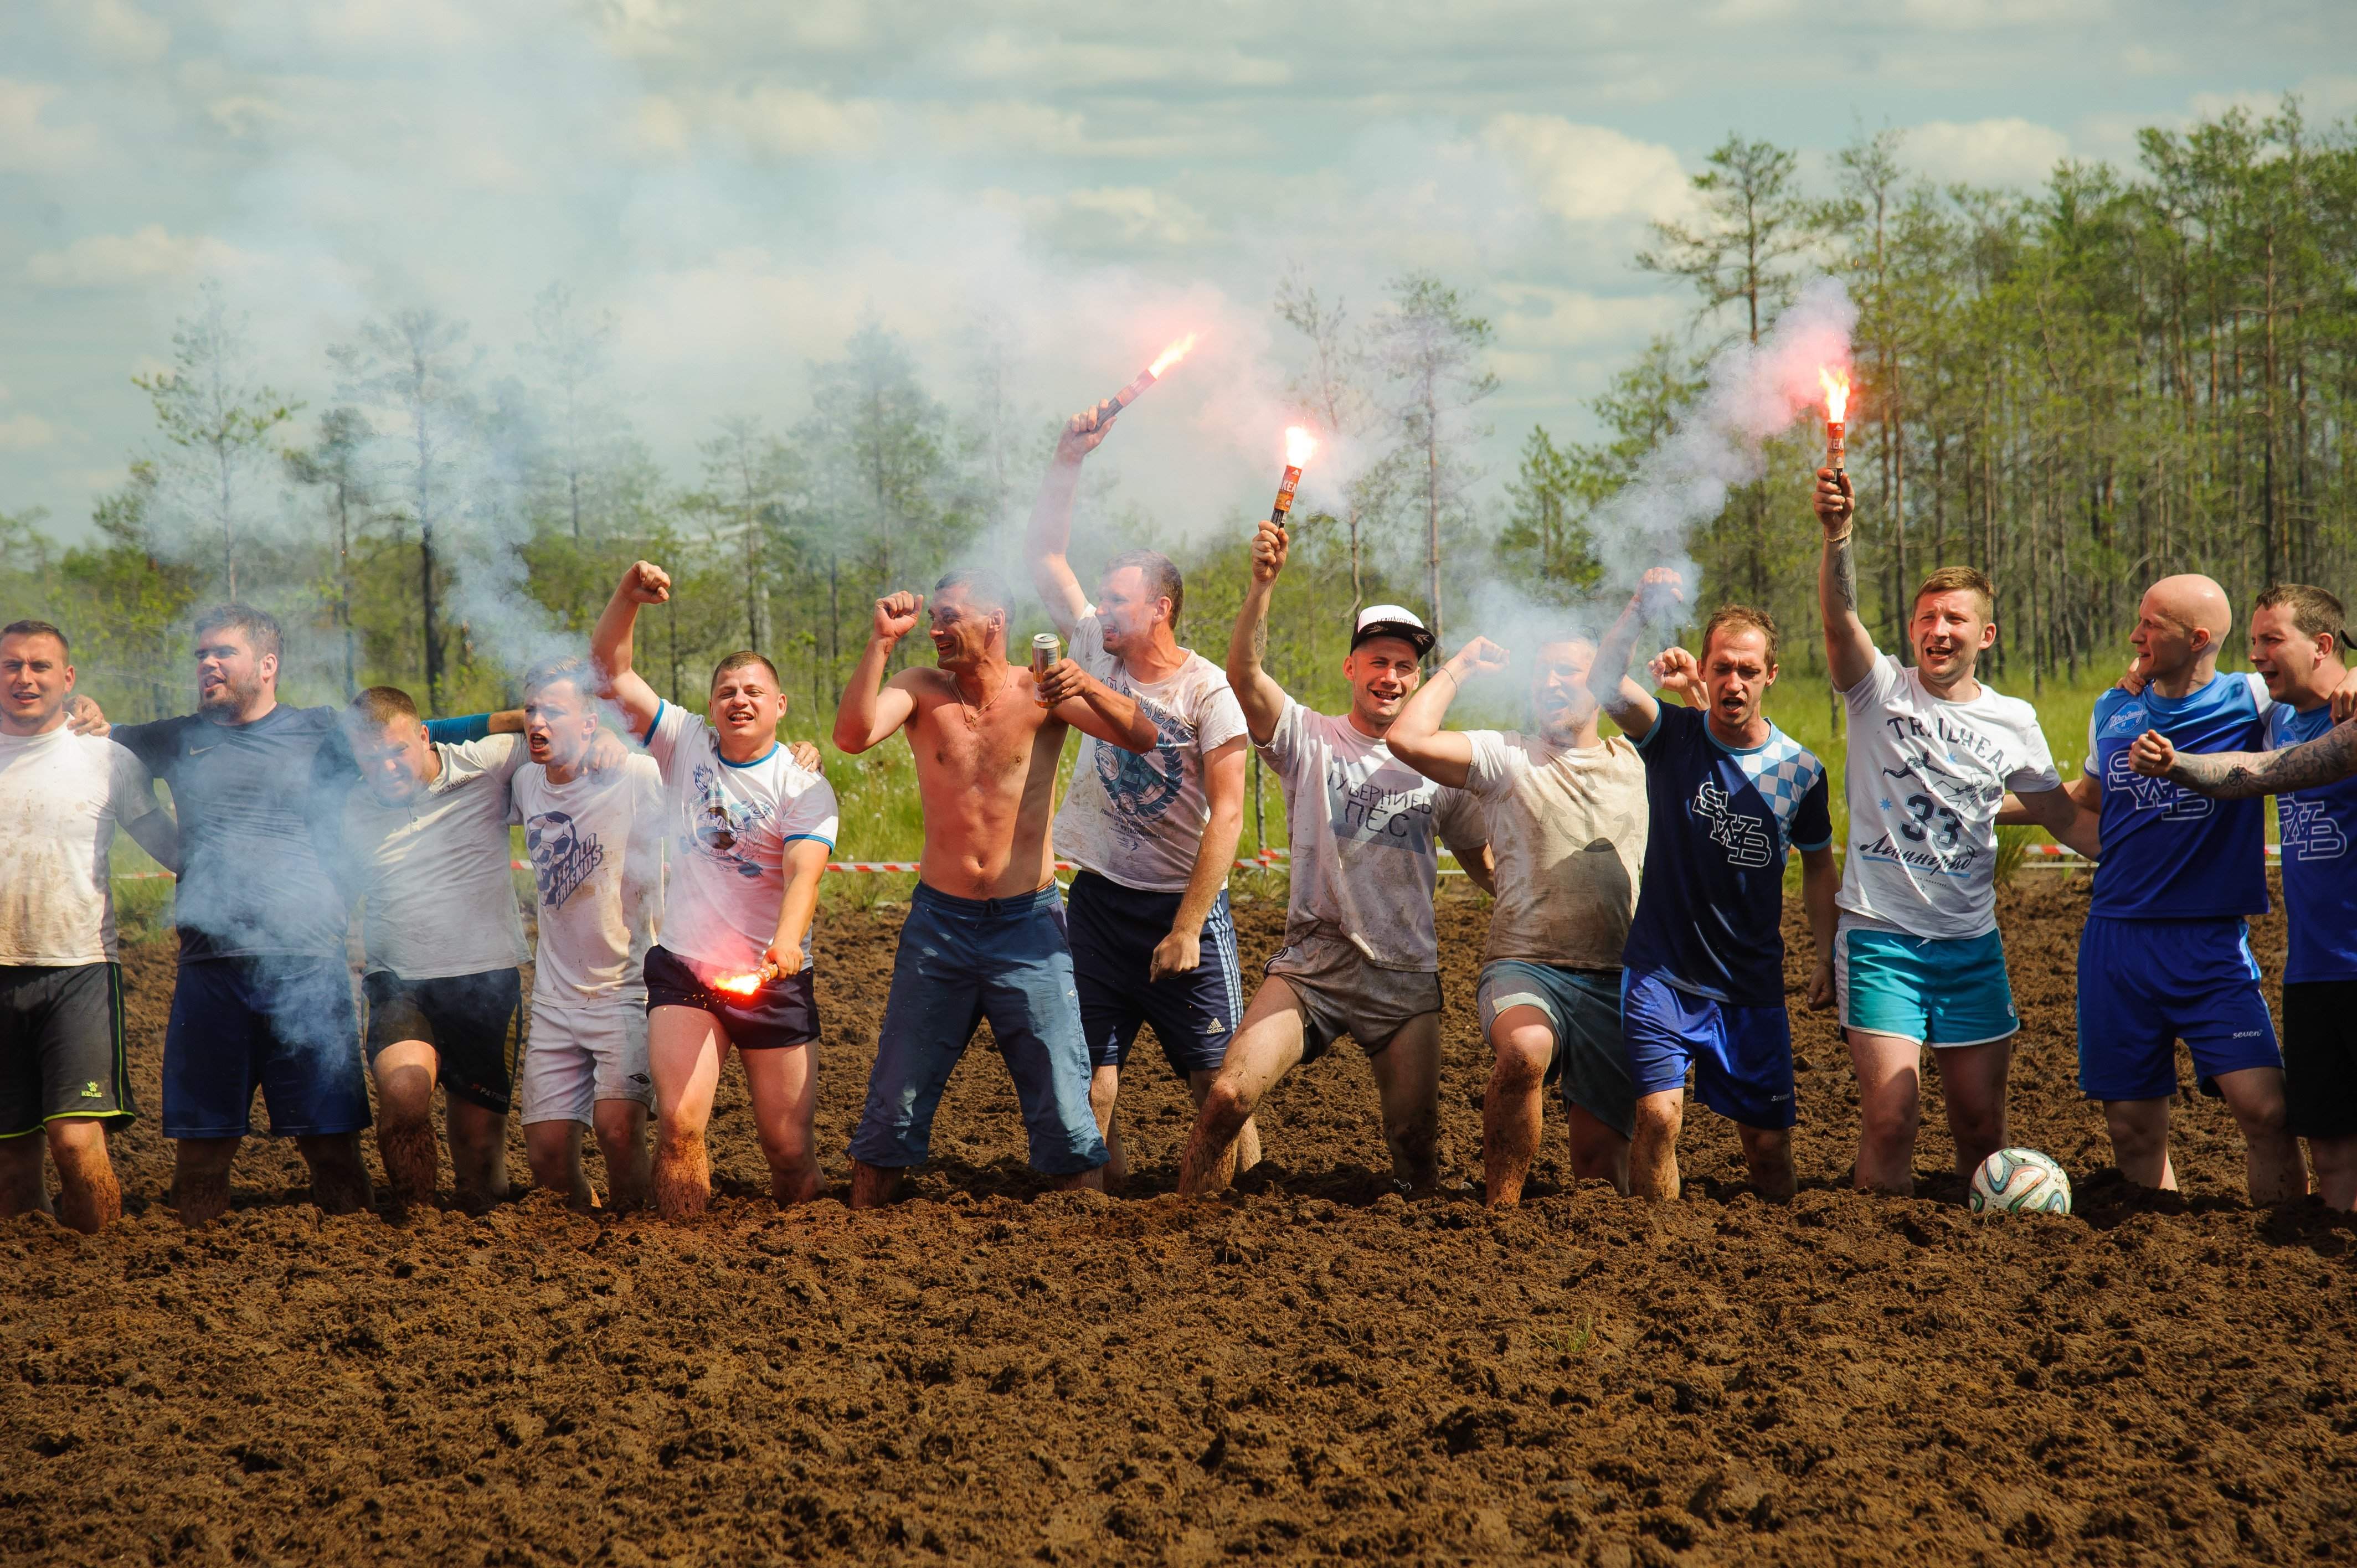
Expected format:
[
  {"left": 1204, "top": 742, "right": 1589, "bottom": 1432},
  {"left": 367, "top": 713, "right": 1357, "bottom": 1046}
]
[{"left": 851, "top": 882, "right": 1105, "bottom": 1177}]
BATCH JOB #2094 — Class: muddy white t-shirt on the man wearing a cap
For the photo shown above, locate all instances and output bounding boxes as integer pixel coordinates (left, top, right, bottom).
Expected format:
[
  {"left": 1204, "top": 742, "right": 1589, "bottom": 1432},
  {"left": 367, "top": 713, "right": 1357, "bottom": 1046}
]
[{"left": 1261, "top": 698, "right": 1485, "bottom": 974}]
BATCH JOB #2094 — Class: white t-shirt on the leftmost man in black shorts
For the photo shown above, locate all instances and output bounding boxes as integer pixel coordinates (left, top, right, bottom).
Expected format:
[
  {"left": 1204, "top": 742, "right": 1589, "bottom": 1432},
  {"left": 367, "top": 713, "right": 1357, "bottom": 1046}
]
[{"left": 0, "top": 724, "right": 163, "bottom": 969}]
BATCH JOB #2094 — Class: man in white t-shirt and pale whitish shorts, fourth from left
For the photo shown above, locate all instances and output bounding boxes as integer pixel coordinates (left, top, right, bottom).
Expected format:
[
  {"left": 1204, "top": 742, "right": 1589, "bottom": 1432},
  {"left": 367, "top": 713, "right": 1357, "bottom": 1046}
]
[{"left": 514, "top": 658, "right": 669, "bottom": 1210}]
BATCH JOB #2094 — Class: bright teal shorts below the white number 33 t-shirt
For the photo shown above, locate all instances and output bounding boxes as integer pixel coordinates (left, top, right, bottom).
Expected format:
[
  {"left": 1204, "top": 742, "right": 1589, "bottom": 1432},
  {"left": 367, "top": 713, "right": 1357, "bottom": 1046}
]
[{"left": 1834, "top": 927, "right": 2023, "bottom": 1049}]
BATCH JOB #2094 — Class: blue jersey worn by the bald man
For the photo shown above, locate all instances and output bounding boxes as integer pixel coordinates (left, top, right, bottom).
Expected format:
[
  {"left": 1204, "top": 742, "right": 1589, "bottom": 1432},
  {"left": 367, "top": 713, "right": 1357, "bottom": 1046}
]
[{"left": 2086, "top": 674, "right": 2274, "bottom": 920}]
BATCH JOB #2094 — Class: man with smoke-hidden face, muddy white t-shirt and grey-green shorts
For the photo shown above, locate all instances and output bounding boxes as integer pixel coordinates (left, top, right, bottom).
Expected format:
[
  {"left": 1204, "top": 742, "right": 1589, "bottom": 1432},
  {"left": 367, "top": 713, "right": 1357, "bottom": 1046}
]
[{"left": 1383, "top": 635, "right": 1645, "bottom": 1207}]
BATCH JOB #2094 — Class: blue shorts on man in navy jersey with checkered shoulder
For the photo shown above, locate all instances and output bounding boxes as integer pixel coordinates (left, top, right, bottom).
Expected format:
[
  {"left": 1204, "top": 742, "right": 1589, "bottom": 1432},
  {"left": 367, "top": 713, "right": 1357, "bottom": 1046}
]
[{"left": 1622, "top": 969, "right": 1801, "bottom": 1132}]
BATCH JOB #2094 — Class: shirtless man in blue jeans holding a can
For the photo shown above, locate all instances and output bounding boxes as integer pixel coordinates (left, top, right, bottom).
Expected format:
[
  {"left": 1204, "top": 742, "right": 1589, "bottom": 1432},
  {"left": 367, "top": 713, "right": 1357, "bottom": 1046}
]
[{"left": 835, "top": 571, "right": 1162, "bottom": 1210}]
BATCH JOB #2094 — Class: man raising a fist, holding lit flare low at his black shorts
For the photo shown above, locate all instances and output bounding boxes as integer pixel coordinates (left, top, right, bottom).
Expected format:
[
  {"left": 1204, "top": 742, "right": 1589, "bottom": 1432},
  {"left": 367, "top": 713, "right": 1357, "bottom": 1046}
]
[{"left": 589, "top": 561, "right": 837, "bottom": 1219}]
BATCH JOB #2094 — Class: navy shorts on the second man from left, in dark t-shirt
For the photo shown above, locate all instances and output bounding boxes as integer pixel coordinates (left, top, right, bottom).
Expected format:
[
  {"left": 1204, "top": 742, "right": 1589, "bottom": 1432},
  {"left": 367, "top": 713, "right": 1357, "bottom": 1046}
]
[{"left": 163, "top": 955, "right": 368, "bottom": 1139}]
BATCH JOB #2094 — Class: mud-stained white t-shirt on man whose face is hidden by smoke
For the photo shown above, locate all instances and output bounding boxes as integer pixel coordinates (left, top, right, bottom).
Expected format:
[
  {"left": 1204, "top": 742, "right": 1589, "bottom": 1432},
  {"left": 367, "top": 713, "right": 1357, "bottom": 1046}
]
[{"left": 1466, "top": 729, "right": 1650, "bottom": 969}]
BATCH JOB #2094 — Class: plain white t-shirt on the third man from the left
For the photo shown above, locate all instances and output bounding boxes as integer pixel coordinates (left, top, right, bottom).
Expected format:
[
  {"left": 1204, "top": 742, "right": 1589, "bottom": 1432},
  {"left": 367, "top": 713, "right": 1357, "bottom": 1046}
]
[{"left": 344, "top": 736, "right": 531, "bottom": 981}]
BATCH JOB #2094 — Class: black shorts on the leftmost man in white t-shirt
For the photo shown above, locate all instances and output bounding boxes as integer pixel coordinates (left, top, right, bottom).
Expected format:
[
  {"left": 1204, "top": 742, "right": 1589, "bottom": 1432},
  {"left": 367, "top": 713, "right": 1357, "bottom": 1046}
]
[{"left": 0, "top": 964, "right": 135, "bottom": 1139}]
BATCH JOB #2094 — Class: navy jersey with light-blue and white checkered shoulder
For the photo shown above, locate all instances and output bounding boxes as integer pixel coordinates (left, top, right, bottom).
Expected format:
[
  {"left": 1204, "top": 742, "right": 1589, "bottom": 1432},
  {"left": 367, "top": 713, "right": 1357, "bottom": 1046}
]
[{"left": 1622, "top": 703, "right": 1834, "bottom": 1007}]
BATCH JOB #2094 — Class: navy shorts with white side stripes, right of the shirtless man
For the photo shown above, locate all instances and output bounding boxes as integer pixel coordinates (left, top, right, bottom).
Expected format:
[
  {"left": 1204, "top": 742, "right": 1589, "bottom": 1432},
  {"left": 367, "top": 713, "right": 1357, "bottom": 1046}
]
[{"left": 1066, "top": 870, "right": 1244, "bottom": 1077}]
